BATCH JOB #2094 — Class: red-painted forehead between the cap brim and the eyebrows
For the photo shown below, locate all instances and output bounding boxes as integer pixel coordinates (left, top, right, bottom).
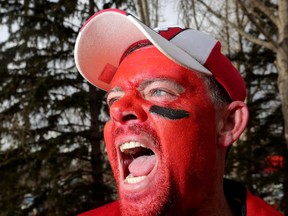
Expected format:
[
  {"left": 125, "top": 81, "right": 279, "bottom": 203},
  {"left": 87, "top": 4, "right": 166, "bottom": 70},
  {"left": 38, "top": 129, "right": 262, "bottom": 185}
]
[{"left": 110, "top": 46, "right": 203, "bottom": 90}]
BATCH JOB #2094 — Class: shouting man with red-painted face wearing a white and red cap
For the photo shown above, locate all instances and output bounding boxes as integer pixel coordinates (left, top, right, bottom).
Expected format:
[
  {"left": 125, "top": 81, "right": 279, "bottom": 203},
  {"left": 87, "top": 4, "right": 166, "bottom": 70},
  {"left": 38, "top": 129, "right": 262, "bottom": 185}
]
[{"left": 75, "top": 9, "right": 281, "bottom": 216}]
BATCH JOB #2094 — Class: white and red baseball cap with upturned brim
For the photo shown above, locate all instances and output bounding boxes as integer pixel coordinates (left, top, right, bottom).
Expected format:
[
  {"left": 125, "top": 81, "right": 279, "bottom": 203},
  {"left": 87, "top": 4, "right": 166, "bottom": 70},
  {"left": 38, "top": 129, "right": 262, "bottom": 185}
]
[{"left": 74, "top": 9, "right": 246, "bottom": 101}]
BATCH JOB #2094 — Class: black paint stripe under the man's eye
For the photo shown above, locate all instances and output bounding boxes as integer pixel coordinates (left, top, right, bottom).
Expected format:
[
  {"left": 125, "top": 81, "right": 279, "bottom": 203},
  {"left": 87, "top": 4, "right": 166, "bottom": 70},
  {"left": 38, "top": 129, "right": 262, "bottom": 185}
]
[{"left": 149, "top": 106, "right": 189, "bottom": 120}]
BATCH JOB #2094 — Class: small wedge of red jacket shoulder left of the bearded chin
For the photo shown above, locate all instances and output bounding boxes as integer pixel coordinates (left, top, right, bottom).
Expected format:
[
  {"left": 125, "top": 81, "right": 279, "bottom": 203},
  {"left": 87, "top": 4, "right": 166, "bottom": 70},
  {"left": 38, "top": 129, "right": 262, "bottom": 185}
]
[{"left": 78, "top": 201, "right": 120, "bottom": 216}]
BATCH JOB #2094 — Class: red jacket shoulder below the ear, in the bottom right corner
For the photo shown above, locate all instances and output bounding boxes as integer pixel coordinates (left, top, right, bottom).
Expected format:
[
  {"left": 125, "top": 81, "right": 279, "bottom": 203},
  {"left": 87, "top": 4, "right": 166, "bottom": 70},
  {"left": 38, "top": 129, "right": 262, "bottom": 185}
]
[{"left": 246, "top": 191, "right": 282, "bottom": 216}]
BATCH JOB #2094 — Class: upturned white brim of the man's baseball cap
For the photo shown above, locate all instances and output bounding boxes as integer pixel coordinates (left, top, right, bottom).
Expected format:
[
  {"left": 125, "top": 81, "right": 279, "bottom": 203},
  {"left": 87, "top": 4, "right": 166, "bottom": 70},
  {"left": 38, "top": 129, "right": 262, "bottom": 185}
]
[{"left": 74, "top": 10, "right": 211, "bottom": 91}]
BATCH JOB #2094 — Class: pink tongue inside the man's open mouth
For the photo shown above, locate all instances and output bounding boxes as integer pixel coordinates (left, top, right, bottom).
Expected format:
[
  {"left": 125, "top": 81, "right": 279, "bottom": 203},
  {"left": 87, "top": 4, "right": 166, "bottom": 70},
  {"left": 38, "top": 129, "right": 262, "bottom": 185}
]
[{"left": 128, "top": 155, "right": 157, "bottom": 177}]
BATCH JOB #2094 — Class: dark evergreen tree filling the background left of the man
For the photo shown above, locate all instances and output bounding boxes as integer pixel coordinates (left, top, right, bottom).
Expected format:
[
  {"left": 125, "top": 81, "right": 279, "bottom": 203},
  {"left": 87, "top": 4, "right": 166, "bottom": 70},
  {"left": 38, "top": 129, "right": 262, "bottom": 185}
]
[{"left": 0, "top": 0, "right": 114, "bottom": 216}]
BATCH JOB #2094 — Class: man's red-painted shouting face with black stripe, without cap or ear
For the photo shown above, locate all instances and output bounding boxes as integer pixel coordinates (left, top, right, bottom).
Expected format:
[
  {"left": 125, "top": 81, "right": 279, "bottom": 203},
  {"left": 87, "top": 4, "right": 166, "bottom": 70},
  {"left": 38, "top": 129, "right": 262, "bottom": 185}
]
[{"left": 104, "top": 46, "right": 216, "bottom": 215}]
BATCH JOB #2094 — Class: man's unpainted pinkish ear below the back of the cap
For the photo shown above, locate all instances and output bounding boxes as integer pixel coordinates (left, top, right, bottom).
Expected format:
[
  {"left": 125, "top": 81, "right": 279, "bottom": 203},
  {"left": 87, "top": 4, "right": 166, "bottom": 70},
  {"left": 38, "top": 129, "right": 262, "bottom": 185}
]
[{"left": 217, "top": 101, "right": 249, "bottom": 148}]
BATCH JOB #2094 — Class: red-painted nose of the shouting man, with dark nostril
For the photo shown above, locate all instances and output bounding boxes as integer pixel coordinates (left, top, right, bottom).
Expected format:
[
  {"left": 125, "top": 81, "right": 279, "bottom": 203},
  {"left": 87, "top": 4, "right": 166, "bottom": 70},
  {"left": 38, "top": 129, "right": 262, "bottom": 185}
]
[{"left": 110, "top": 94, "right": 147, "bottom": 124}]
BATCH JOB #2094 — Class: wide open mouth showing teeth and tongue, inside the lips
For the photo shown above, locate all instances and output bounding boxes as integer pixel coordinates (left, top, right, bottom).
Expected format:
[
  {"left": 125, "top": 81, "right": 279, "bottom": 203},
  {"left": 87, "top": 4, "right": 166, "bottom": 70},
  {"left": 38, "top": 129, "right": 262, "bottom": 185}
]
[{"left": 120, "top": 141, "right": 157, "bottom": 184}]
